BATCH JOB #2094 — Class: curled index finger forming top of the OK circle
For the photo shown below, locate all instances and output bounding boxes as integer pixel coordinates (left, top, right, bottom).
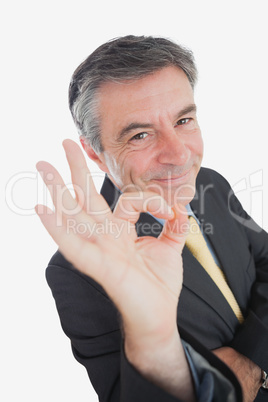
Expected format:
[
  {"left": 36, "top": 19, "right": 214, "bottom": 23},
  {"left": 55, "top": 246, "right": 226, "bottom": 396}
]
[{"left": 114, "top": 191, "right": 174, "bottom": 223}]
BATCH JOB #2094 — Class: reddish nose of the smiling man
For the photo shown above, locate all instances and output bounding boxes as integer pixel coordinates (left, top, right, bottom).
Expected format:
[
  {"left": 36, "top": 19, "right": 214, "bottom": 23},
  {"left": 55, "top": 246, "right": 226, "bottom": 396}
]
[{"left": 158, "top": 129, "right": 191, "bottom": 166}]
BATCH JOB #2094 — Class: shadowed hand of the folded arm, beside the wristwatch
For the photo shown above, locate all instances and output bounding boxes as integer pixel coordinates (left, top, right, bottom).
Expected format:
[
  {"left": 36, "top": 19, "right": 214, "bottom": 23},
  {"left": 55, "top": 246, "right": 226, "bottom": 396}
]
[{"left": 213, "top": 347, "right": 261, "bottom": 402}]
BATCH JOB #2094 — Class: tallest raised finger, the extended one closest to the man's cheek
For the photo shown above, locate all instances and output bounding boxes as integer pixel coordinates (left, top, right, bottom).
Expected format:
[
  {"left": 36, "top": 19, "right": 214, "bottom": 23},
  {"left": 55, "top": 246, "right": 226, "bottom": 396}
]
[{"left": 63, "top": 140, "right": 111, "bottom": 219}]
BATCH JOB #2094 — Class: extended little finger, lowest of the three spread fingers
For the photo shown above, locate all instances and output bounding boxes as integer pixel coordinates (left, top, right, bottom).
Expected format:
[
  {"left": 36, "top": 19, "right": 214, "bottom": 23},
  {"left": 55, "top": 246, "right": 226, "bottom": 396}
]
[{"left": 35, "top": 205, "right": 103, "bottom": 282}]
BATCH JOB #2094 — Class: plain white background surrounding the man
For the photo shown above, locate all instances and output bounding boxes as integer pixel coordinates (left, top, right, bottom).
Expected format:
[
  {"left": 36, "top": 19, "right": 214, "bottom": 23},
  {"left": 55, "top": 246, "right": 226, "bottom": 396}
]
[{"left": 0, "top": 0, "right": 268, "bottom": 402}]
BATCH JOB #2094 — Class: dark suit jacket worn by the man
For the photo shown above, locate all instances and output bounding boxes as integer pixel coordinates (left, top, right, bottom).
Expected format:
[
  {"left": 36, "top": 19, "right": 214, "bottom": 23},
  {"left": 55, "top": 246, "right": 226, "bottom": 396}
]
[{"left": 47, "top": 169, "right": 268, "bottom": 402}]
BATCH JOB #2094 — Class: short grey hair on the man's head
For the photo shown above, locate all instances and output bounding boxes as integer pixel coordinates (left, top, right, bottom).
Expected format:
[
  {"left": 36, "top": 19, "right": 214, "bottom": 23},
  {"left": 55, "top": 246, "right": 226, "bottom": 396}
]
[{"left": 69, "top": 35, "right": 197, "bottom": 153}]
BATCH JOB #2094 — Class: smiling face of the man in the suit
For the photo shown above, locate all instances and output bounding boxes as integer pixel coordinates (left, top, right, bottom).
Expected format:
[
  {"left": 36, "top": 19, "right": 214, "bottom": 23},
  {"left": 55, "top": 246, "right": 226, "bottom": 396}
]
[{"left": 93, "top": 66, "right": 203, "bottom": 205}]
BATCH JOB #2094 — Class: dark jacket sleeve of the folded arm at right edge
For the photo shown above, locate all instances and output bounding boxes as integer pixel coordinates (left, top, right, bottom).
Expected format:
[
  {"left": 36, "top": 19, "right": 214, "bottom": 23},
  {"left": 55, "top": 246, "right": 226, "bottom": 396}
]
[{"left": 229, "top": 189, "right": 268, "bottom": 371}]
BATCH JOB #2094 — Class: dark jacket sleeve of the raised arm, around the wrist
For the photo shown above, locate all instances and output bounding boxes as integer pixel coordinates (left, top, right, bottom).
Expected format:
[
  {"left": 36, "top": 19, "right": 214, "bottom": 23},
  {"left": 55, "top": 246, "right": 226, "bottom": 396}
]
[{"left": 46, "top": 253, "right": 240, "bottom": 402}]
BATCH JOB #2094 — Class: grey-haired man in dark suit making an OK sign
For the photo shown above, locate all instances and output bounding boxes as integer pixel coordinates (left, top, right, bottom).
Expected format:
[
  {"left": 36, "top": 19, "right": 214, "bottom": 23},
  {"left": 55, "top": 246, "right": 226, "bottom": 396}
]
[{"left": 36, "top": 37, "right": 268, "bottom": 401}]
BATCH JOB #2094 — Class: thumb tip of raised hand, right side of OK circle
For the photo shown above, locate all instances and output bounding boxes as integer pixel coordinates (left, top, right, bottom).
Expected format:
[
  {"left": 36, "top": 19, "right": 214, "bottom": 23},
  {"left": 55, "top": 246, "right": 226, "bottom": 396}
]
[{"left": 159, "top": 204, "right": 189, "bottom": 252}]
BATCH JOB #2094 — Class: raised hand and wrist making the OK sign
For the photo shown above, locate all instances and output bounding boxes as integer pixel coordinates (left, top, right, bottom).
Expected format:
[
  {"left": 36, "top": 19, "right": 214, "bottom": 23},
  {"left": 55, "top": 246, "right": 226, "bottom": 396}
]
[{"left": 36, "top": 140, "right": 193, "bottom": 400}]
